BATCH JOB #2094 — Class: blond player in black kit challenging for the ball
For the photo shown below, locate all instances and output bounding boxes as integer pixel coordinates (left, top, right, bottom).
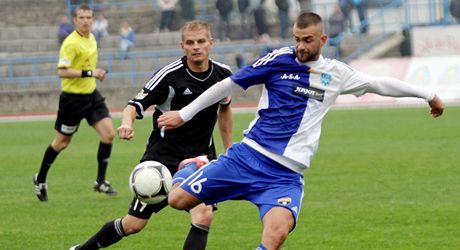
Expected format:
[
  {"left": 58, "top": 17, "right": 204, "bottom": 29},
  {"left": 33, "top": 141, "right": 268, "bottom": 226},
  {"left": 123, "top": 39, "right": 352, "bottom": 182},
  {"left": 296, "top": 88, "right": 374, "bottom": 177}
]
[{"left": 74, "top": 21, "right": 232, "bottom": 250}]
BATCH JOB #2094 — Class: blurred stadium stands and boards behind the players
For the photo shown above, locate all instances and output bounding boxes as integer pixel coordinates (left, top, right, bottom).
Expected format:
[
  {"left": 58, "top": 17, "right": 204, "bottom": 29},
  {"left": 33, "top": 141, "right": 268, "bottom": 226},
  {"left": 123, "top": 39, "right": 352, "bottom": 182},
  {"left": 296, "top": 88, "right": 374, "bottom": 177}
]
[{"left": 0, "top": 0, "right": 460, "bottom": 115}]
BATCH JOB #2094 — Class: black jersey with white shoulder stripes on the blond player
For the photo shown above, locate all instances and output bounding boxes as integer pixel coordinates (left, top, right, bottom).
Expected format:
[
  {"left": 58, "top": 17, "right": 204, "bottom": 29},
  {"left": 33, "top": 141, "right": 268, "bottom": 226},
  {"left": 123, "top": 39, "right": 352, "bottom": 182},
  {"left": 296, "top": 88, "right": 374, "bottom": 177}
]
[{"left": 129, "top": 56, "right": 231, "bottom": 170}]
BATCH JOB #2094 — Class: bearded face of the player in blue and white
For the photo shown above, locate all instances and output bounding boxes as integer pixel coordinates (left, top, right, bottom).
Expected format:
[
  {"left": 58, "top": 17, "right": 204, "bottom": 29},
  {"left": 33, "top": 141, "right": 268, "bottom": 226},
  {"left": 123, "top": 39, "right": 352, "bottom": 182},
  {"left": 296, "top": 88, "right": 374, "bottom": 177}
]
[{"left": 293, "top": 24, "right": 327, "bottom": 62}]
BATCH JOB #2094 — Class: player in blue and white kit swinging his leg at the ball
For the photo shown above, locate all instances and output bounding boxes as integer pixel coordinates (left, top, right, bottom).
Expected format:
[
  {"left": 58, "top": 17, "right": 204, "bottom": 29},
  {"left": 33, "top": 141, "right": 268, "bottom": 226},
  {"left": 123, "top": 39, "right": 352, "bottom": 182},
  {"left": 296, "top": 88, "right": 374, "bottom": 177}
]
[{"left": 158, "top": 13, "right": 444, "bottom": 249}]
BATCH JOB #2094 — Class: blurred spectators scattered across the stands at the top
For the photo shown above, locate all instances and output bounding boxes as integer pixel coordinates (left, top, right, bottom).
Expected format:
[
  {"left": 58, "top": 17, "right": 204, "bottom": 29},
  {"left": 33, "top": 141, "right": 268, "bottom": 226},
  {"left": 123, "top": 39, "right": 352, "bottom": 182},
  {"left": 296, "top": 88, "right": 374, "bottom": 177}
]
[{"left": 58, "top": 0, "right": 460, "bottom": 58}]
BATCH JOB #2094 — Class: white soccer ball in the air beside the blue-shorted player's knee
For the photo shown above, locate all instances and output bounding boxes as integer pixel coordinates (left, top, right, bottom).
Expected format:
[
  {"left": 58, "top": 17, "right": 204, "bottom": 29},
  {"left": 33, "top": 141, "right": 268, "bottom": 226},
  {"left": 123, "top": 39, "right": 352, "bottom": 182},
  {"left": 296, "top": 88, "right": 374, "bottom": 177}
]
[{"left": 129, "top": 161, "right": 172, "bottom": 204}]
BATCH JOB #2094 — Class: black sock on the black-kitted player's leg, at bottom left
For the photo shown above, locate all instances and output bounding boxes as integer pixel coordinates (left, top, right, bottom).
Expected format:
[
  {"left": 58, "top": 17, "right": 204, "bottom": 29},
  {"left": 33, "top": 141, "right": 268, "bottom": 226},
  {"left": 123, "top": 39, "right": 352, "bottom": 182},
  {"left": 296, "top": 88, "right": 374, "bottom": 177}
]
[{"left": 77, "top": 218, "right": 126, "bottom": 250}]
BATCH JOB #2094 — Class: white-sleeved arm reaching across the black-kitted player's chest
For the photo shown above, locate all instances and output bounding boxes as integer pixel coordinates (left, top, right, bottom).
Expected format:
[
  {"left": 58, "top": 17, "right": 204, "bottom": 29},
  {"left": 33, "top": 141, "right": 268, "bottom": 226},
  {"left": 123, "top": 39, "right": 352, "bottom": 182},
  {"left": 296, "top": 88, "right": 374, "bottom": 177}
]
[{"left": 158, "top": 77, "right": 243, "bottom": 129}]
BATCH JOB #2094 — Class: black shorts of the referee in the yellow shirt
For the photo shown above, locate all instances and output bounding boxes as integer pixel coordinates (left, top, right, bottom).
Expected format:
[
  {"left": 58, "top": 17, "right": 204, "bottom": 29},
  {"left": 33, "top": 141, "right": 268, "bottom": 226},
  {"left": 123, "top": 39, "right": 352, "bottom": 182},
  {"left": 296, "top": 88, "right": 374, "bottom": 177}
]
[{"left": 54, "top": 90, "right": 110, "bottom": 135}]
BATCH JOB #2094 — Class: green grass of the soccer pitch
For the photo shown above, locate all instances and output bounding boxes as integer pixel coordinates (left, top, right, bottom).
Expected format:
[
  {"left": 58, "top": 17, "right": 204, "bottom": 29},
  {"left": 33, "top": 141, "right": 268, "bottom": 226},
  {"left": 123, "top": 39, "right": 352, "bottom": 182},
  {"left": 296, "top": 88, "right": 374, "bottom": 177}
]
[{"left": 0, "top": 107, "right": 460, "bottom": 250}]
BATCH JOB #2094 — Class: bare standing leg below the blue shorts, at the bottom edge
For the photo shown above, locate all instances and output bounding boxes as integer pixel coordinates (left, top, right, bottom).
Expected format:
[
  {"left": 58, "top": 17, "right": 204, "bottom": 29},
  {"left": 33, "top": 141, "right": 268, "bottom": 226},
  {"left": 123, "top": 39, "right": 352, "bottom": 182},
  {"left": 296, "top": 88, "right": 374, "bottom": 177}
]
[{"left": 262, "top": 207, "right": 295, "bottom": 250}]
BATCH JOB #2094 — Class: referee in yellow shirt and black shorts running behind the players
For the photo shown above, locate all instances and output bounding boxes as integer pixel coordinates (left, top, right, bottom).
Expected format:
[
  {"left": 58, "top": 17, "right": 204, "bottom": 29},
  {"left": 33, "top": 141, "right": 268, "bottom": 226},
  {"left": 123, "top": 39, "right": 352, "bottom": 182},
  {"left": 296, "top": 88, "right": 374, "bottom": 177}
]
[{"left": 33, "top": 4, "right": 117, "bottom": 201}]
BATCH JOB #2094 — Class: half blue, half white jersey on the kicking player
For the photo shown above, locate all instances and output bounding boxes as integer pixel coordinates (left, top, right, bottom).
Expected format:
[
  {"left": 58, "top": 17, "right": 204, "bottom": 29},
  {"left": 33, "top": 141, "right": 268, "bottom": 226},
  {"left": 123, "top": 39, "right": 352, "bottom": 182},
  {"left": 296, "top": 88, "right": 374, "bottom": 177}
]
[{"left": 231, "top": 47, "right": 430, "bottom": 173}]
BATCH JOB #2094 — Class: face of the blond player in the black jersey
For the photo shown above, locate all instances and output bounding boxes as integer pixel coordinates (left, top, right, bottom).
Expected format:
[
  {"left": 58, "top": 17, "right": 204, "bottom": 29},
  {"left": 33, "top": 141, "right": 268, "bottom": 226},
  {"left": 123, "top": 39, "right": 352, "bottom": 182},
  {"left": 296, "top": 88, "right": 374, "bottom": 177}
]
[{"left": 181, "top": 29, "right": 213, "bottom": 65}]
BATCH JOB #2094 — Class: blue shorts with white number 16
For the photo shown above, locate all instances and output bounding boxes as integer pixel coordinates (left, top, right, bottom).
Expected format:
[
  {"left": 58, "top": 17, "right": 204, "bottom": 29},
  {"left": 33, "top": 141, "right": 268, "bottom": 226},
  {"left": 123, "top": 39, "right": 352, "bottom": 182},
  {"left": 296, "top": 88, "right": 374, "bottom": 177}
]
[{"left": 180, "top": 143, "right": 304, "bottom": 221}]
